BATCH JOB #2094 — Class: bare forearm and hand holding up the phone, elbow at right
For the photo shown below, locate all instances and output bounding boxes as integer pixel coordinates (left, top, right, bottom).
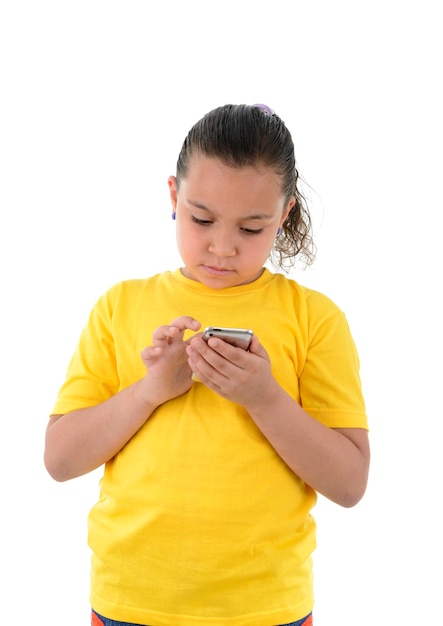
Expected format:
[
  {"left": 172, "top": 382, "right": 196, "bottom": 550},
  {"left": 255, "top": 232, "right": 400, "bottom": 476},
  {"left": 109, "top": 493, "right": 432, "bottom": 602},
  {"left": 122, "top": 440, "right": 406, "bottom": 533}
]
[{"left": 187, "top": 337, "right": 369, "bottom": 507}]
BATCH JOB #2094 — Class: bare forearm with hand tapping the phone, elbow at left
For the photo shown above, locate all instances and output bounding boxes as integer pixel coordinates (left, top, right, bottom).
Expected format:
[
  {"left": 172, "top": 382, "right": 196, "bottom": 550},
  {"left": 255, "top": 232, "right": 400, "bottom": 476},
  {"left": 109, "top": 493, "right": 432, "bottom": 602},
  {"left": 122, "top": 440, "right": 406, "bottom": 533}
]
[{"left": 44, "top": 316, "right": 200, "bottom": 481}]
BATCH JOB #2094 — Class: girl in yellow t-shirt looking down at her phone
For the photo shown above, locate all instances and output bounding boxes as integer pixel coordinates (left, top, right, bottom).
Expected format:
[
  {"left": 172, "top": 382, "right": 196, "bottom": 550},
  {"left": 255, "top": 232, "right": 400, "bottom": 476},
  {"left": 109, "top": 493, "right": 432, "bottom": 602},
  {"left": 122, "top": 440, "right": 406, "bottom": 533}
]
[{"left": 45, "top": 105, "right": 369, "bottom": 626}]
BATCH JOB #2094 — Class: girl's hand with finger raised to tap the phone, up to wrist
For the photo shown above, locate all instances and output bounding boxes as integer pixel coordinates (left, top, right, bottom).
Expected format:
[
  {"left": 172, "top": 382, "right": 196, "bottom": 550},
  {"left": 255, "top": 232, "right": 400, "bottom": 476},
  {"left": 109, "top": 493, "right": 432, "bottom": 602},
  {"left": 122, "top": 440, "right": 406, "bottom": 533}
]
[{"left": 141, "top": 315, "right": 201, "bottom": 406}]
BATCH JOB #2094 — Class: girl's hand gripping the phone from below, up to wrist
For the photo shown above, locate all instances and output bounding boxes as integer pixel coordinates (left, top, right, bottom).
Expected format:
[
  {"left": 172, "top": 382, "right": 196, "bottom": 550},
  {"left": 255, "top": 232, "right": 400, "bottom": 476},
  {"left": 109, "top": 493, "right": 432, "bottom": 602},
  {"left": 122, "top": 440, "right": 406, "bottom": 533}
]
[{"left": 186, "top": 335, "right": 276, "bottom": 409}]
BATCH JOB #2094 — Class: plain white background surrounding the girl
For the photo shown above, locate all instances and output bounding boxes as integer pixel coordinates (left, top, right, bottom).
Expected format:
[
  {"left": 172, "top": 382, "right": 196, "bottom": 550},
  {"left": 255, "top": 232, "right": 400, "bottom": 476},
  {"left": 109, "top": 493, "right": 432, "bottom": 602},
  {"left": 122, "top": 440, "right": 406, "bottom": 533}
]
[{"left": 0, "top": 0, "right": 443, "bottom": 626}]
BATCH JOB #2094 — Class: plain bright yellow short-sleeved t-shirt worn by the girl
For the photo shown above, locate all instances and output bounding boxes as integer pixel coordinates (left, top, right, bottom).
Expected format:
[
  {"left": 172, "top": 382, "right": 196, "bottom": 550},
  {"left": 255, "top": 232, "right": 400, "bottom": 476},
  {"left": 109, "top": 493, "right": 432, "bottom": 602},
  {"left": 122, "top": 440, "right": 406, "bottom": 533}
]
[{"left": 53, "top": 270, "right": 367, "bottom": 626}]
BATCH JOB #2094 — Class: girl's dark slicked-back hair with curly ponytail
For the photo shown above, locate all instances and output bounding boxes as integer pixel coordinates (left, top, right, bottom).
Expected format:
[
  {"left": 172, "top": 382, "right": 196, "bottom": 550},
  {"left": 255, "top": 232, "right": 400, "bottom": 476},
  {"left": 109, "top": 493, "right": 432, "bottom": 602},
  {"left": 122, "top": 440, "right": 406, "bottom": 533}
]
[{"left": 176, "top": 104, "right": 315, "bottom": 269}]
